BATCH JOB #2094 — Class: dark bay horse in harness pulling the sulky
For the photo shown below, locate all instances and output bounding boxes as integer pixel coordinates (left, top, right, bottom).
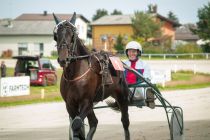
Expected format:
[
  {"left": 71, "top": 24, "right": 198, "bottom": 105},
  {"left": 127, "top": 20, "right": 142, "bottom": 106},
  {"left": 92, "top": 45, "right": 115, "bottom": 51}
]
[{"left": 53, "top": 13, "right": 130, "bottom": 140}]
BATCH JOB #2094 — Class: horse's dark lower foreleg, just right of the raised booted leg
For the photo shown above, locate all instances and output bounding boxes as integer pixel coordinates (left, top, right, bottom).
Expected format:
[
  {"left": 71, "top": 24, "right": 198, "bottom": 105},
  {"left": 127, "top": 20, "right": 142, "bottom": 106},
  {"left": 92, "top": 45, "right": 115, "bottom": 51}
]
[{"left": 86, "top": 109, "right": 98, "bottom": 140}]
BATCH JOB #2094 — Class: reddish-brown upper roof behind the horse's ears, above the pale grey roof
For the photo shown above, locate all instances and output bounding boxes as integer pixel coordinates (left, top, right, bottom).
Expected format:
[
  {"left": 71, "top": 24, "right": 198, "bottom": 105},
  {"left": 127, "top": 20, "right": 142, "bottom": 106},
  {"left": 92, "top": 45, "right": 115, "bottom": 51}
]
[{"left": 15, "top": 12, "right": 89, "bottom": 23}]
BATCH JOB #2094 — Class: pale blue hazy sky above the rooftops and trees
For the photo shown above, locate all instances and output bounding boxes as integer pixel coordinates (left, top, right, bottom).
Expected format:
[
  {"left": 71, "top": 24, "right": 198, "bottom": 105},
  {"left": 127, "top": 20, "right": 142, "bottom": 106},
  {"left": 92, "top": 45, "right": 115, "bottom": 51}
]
[{"left": 0, "top": 0, "right": 210, "bottom": 24}]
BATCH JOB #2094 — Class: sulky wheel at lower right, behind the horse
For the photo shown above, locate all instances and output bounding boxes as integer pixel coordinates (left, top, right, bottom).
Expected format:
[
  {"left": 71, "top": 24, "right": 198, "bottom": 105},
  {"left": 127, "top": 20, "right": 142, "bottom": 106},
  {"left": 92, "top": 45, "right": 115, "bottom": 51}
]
[{"left": 170, "top": 108, "right": 184, "bottom": 140}]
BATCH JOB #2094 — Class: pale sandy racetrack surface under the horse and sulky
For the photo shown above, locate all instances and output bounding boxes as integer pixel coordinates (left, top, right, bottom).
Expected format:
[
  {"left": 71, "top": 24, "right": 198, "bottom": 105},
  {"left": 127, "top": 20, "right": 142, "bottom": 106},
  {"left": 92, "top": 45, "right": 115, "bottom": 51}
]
[{"left": 0, "top": 88, "right": 210, "bottom": 140}]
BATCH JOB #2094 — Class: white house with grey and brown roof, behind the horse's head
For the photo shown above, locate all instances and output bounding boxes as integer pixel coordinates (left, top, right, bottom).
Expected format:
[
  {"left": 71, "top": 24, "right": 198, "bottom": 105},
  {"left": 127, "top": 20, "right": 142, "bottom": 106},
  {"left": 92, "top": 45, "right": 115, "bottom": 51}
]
[{"left": 0, "top": 11, "right": 89, "bottom": 56}]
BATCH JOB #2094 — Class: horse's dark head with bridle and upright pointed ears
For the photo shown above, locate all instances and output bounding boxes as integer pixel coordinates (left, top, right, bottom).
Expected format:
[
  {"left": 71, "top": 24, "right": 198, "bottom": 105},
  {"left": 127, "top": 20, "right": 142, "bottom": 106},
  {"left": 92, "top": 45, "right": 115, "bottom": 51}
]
[{"left": 53, "top": 13, "right": 77, "bottom": 67}]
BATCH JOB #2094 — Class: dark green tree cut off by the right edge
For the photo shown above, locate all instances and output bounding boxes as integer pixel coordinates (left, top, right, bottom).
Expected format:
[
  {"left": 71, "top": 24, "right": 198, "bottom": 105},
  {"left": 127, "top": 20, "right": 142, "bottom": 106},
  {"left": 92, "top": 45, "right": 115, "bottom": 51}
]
[{"left": 192, "top": 2, "right": 210, "bottom": 52}]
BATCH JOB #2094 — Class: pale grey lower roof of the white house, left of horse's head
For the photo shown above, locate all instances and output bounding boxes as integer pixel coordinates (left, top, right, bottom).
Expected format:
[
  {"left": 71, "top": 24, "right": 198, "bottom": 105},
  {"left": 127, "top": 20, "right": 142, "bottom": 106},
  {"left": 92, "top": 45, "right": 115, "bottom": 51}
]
[{"left": 0, "top": 20, "right": 55, "bottom": 36}]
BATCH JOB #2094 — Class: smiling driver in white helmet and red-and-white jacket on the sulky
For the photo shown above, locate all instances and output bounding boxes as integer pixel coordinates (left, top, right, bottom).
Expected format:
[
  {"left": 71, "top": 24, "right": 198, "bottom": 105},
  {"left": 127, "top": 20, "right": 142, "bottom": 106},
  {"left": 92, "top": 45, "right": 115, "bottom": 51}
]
[{"left": 125, "top": 41, "right": 155, "bottom": 109}]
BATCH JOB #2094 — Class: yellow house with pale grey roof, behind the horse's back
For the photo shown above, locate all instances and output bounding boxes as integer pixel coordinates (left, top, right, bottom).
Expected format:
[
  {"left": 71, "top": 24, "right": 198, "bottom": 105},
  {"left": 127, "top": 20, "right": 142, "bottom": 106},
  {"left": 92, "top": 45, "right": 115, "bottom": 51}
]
[{"left": 91, "top": 15, "right": 132, "bottom": 50}]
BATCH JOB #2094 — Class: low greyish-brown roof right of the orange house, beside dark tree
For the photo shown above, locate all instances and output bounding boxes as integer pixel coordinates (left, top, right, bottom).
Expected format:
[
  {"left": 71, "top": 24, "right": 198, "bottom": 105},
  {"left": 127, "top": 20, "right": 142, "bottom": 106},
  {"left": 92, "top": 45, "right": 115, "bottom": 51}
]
[{"left": 175, "top": 24, "right": 199, "bottom": 40}]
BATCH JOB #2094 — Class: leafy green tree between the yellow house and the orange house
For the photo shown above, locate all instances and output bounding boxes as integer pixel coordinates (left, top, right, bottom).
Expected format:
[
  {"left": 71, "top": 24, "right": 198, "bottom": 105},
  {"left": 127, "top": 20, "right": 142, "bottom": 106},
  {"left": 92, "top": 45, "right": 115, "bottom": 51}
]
[{"left": 131, "top": 11, "right": 161, "bottom": 42}]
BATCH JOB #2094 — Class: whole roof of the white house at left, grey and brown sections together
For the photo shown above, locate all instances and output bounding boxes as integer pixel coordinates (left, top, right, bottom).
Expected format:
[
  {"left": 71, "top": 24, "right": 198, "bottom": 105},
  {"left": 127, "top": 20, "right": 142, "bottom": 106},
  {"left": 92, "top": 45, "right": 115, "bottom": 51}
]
[{"left": 0, "top": 13, "right": 89, "bottom": 36}]
